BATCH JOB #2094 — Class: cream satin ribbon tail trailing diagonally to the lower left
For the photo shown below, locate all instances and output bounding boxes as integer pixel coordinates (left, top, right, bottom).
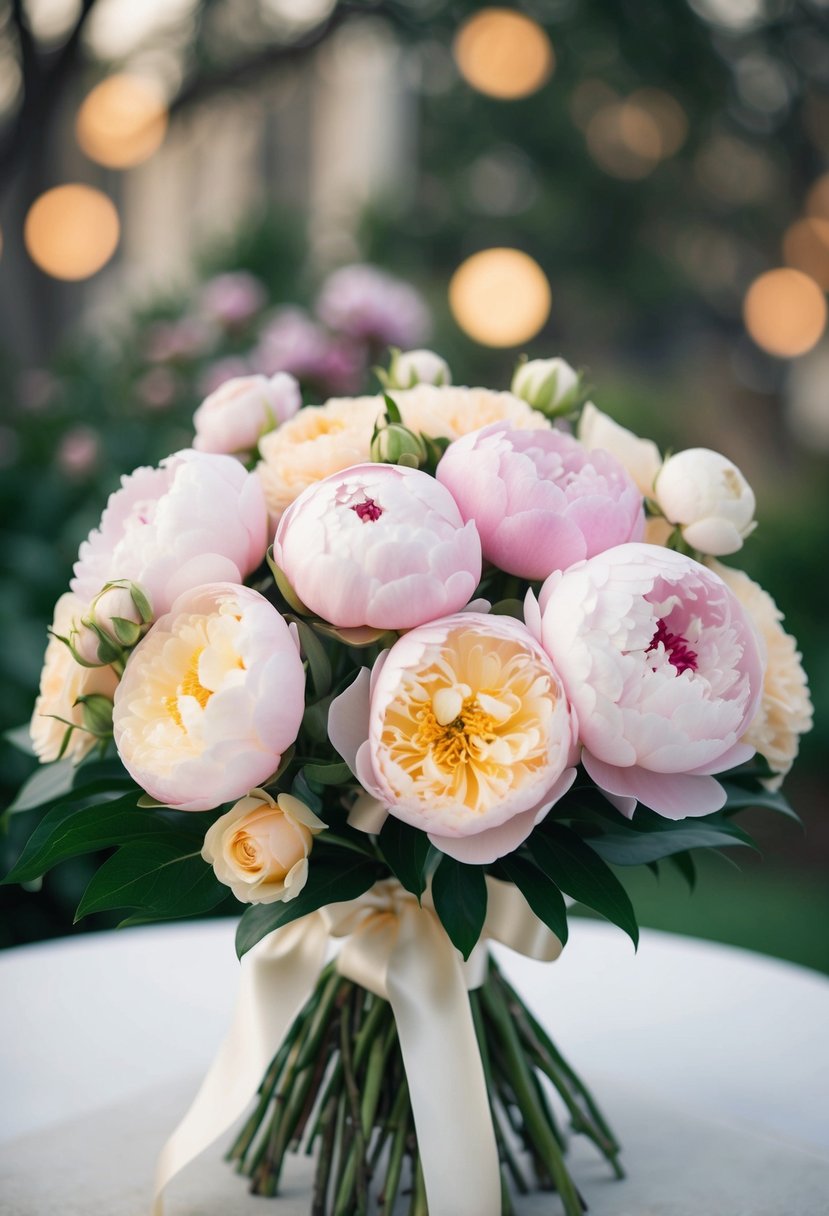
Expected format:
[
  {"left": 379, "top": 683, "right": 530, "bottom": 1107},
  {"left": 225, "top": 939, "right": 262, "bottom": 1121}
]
[{"left": 152, "top": 913, "right": 328, "bottom": 1216}]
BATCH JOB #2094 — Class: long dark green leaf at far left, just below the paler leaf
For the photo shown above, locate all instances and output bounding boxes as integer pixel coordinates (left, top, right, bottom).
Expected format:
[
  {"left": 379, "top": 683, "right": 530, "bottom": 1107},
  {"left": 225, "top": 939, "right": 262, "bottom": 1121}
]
[{"left": 2, "top": 793, "right": 190, "bottom": 884}]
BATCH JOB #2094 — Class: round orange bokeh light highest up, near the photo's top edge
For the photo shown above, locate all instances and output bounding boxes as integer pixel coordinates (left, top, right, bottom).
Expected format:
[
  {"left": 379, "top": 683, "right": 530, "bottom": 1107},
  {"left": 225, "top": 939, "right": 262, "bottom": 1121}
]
[{"left": 453, "top": 9, "right": 556, "bottom": 101}]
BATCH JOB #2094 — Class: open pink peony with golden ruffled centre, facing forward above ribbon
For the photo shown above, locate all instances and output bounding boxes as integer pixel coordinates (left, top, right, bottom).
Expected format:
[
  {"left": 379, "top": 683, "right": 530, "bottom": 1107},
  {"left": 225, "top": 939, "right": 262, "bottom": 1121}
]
[{"left": 328, "top": 612, "right": 575, "bottom": 865}]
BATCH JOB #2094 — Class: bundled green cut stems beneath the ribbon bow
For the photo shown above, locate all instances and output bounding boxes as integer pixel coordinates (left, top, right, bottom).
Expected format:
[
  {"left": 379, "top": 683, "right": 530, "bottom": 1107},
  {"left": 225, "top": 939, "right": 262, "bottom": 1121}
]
[{"left": 227, "top": 959, "right": 624, "bottom": 1216}]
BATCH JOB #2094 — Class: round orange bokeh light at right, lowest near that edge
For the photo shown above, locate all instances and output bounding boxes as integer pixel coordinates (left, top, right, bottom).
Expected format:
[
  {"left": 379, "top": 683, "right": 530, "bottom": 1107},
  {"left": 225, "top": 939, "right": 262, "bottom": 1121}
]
[{"left": 743, "top": 268, "right": 827, "bottom": 359}]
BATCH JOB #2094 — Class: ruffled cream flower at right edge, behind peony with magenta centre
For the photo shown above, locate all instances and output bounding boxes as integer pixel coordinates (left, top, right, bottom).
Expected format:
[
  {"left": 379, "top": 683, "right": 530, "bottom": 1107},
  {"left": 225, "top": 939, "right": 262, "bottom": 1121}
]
[{"left": 709, "top": 561, "right": 812, "bottom": 789}]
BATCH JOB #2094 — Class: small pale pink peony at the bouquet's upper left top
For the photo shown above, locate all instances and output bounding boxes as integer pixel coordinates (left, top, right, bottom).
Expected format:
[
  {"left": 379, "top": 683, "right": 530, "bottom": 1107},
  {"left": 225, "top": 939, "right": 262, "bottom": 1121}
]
[{"left": 193, "top": 372, "right": 303, "bottom": 456}]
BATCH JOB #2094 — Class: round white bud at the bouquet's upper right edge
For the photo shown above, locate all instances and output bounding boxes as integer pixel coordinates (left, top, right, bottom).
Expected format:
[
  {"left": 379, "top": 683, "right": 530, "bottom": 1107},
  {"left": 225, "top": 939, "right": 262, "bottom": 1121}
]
[{"left": 654, "top": 447, "right": 756, "bottom": 557}]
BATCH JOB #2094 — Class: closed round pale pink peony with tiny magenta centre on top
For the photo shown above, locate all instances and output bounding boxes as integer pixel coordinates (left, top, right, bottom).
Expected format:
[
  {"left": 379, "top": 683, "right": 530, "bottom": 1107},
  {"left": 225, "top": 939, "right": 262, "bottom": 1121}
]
[{"left": 273, "top": 465, "right": 481, "bottom": 629}]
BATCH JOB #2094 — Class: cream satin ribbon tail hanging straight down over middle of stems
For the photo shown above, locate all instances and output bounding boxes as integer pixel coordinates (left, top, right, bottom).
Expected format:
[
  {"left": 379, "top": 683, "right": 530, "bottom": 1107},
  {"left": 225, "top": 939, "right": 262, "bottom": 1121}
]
[{"left": 385, "top": 908, "right": 501, "bottom": 1216}]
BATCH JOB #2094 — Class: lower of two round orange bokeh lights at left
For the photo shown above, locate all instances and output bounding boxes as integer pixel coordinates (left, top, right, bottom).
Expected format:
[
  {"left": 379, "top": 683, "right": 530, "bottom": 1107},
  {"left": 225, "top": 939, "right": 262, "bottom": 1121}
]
[{"left": 23, "top": 184, "right": 120, "bottom": 280}]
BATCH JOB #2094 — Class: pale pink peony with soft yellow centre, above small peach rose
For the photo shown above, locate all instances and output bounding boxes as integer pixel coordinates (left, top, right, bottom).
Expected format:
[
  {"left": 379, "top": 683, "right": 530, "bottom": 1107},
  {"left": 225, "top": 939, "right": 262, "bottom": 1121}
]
[{"left": 112, "top": 582, "right": 305, "bottom": 811}]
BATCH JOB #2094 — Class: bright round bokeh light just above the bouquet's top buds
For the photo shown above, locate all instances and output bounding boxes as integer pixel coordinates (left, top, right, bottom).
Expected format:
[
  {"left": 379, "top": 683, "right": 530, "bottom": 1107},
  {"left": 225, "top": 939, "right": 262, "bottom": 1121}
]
[{"left": 449, "top": 248, "right": 552, "bottom": 347}]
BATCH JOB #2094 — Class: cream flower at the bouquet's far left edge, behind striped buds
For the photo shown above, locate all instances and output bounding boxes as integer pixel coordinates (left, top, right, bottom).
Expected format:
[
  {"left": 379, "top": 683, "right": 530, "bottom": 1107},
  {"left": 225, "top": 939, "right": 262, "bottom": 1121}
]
[{"left": 29, "top": 591, "right": 118, "bottom": 764}]
